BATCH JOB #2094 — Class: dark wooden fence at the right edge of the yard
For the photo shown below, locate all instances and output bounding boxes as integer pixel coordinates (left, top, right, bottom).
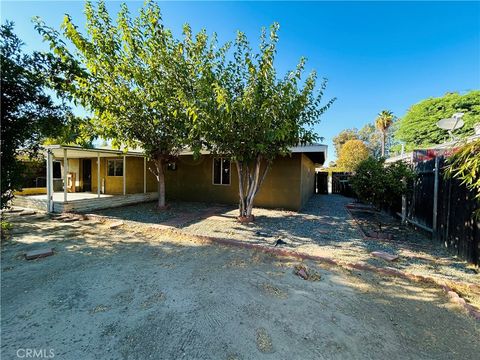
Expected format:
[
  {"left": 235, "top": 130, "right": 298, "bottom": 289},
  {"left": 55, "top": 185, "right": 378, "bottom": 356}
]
[{"left": 402, "top": 150, "right": 480, "bottom": 265}]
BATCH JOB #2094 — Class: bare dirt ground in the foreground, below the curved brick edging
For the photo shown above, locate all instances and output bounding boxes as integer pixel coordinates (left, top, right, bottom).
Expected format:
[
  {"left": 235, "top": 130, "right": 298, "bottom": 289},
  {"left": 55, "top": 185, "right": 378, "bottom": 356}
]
[{"left": 1, "top": 215, "right": 480, "bottom": 359}]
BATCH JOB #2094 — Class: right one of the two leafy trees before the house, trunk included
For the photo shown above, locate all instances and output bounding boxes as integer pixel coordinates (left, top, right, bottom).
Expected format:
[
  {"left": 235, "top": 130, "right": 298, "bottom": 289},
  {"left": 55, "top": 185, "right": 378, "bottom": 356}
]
[{"left": 190, "top": 24, "right": 334, "bottom": 221}]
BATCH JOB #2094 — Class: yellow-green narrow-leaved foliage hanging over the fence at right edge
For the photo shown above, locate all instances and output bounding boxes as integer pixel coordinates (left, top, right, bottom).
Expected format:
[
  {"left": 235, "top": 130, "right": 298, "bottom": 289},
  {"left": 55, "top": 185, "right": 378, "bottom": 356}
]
[{"left": 445, "top": 140, "right": 480, "bottom": 220}]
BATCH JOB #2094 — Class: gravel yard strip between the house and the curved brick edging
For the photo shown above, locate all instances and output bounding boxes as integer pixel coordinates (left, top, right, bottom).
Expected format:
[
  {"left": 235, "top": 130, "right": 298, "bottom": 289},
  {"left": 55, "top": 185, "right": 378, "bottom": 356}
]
[{"left": 84, "top": 195, "right": 480, "bottom": 296}]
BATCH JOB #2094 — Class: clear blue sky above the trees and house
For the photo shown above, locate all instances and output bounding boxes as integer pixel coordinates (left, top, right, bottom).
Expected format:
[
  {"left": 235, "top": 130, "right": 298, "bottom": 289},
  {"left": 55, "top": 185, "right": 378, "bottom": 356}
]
[{"left": 1, "top": 1, "right": 480, "bottom": 161}]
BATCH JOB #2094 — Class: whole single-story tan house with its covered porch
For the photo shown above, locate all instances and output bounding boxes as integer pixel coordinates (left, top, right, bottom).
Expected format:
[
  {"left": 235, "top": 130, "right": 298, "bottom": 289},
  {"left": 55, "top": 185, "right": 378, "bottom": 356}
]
[{"left": 14, "top": 144, "right": 327, "bottom": 212}]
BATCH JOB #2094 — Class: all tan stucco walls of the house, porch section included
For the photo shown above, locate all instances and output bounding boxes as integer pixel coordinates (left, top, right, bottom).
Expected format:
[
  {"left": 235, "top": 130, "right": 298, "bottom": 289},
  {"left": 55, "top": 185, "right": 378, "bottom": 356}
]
[{"left": 58, "top": 153, "right": 315, "bottom": 210}]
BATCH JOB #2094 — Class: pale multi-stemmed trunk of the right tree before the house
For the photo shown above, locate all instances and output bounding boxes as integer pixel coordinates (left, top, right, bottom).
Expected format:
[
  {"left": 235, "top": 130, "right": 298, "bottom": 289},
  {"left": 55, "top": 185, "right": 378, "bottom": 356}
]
[{"left": 236, "top": 156, "right": 270, "bottom": 222}]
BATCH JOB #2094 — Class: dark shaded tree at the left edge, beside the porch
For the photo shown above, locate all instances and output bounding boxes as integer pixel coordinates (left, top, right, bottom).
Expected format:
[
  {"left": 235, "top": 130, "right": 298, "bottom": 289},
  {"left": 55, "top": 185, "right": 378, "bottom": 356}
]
[{"left": 0, "top": 22, "right": 76, "bottom": 208}]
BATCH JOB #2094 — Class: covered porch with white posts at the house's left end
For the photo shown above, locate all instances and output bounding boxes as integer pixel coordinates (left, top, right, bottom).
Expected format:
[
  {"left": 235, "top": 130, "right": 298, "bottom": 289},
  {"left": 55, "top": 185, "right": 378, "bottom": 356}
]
[{"left": 14, "top": 145, "right": 158, "bottom": 213}]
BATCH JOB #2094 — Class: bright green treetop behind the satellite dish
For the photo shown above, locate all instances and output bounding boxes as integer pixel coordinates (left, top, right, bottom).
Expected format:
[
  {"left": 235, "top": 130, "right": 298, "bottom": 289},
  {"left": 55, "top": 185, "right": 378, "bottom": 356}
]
[{"left": 395, "top": 90, "right": 480, "bottom": 151}]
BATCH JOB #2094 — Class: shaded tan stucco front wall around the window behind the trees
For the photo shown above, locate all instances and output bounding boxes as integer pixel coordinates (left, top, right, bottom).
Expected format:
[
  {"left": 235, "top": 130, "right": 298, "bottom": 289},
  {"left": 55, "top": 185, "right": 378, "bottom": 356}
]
[{"left": 166, "top": 154, "right": 302, "bottom": 210}]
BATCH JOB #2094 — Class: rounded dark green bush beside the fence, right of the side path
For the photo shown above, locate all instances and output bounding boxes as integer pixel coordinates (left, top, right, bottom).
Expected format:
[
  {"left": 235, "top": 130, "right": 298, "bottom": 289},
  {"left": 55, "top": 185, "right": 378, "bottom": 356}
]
[{"left": 350, "top": 157, "right": 415, "bottom": 208}]
